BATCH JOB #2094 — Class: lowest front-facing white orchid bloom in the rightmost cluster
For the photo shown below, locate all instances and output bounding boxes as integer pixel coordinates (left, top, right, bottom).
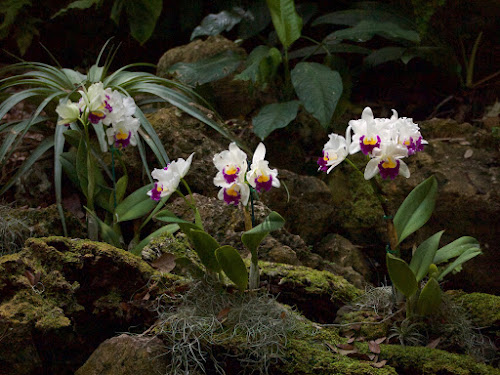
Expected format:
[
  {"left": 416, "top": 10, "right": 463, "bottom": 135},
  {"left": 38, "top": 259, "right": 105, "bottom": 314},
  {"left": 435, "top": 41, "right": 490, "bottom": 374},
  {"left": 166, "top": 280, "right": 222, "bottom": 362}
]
[{"left": 364, "top": 143, "right": 410, "bottom": 180}]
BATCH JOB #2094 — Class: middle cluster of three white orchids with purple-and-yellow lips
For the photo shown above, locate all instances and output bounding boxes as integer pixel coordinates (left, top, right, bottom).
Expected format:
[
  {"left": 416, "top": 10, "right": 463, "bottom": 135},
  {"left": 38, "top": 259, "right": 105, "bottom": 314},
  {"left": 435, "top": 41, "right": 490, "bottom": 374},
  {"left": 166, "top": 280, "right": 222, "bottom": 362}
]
[{"left": 213, "top": 142, "right": 280, "bottom": 206}]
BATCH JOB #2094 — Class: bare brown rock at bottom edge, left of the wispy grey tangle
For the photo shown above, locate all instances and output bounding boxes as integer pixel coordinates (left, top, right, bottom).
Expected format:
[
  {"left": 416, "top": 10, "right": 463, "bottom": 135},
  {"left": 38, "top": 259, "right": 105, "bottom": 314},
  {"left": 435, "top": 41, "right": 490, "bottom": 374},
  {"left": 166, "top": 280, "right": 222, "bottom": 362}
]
[{"left": 75, "top": 335, "right": 167, "bottom": 375}]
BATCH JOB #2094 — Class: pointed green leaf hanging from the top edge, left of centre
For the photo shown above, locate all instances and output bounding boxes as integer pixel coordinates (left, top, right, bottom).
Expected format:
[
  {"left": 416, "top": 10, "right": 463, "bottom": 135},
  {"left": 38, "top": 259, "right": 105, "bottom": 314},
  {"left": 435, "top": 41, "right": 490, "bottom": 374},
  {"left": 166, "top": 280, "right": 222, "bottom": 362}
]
[{"left": 124, "top": 0, "right": 163, "bottom": 44}]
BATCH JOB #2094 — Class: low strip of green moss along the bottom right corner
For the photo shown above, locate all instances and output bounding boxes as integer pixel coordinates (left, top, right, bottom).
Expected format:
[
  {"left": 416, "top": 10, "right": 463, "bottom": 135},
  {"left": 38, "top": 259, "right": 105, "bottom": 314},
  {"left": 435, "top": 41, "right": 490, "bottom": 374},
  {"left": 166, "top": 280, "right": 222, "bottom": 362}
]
[{"left": 372, "top": 344, "right": 500, "bottom": 375}]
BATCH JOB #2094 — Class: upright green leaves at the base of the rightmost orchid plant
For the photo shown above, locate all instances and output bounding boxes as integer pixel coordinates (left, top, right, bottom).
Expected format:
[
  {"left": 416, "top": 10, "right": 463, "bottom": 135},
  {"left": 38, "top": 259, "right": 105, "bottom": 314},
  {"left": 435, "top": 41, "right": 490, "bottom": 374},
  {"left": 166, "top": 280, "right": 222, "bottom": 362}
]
[{"left": 386, "top": 176, "right": 481, "bottom": 318}]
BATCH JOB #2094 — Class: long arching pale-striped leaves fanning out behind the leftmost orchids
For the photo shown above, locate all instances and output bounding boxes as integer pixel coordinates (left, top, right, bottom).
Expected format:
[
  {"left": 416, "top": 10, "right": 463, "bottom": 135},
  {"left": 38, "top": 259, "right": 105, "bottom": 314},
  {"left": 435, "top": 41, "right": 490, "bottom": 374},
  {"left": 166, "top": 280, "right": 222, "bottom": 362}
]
[{"left": 0, "top": 41, "right": 236, "bottom": 232}]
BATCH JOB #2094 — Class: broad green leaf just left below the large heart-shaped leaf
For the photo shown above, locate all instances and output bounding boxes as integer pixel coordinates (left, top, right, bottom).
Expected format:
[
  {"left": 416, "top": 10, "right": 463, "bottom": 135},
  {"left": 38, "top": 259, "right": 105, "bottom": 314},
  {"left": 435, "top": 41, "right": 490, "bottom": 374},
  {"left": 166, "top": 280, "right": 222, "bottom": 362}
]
[{"left": 252, "top": 100, "right": 300, "bottom": 140}]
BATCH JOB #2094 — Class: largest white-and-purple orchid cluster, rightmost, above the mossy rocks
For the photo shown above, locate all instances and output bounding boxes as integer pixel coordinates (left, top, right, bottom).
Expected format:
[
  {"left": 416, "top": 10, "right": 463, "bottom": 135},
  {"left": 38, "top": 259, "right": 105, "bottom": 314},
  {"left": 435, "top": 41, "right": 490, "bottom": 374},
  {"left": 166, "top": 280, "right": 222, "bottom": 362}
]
[{"left": 318, "top": 107, "right": 427, "bottom": 180}]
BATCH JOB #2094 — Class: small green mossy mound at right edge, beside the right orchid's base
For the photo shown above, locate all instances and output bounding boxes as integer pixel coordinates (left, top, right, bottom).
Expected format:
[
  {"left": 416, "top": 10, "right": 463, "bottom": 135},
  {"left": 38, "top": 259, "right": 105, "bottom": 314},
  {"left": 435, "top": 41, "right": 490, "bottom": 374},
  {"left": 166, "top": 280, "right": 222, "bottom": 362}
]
[{"left": 448, "top": 291, "right": 500, "bottom": 327}]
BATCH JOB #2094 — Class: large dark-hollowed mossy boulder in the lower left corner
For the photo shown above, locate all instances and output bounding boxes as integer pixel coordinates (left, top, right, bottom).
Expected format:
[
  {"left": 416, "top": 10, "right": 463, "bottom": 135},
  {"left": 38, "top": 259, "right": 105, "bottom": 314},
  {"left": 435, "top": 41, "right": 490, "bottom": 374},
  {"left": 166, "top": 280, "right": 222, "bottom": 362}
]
[{"left": 0, "top": 237, "right": 185, "bottom": 374}]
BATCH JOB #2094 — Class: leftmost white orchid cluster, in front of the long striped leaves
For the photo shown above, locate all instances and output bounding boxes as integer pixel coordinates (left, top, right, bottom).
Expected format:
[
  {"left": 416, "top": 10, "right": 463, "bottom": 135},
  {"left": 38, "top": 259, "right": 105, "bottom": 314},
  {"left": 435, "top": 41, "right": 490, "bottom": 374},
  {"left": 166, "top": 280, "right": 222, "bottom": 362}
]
[{"left": 56, "top": 82, "right": 140, "bottom": 152}]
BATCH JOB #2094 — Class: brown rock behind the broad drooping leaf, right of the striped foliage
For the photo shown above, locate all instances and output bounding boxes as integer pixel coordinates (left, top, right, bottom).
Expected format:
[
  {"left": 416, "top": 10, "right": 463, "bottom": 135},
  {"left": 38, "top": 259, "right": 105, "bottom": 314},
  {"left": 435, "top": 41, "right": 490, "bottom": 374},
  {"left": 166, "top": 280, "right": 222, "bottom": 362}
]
[{"left": 157, "top": 35, "right": 257, "bottom": 118}]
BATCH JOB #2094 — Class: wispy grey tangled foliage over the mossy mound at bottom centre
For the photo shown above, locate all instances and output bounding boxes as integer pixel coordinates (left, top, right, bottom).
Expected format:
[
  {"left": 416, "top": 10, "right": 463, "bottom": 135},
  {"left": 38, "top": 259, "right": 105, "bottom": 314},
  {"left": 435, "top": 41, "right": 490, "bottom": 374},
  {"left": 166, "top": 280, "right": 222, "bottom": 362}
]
[{"left": 153, "top": 282, "right": 306, "bottom": 374}]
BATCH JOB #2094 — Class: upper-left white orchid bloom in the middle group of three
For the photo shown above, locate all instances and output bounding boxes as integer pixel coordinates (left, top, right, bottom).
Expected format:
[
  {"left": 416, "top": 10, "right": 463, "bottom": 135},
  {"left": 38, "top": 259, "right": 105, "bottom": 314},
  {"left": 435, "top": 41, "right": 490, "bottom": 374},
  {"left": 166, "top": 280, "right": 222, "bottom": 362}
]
[{"left": 213, "top": 142, "right": 248, "bottom": 187}]
